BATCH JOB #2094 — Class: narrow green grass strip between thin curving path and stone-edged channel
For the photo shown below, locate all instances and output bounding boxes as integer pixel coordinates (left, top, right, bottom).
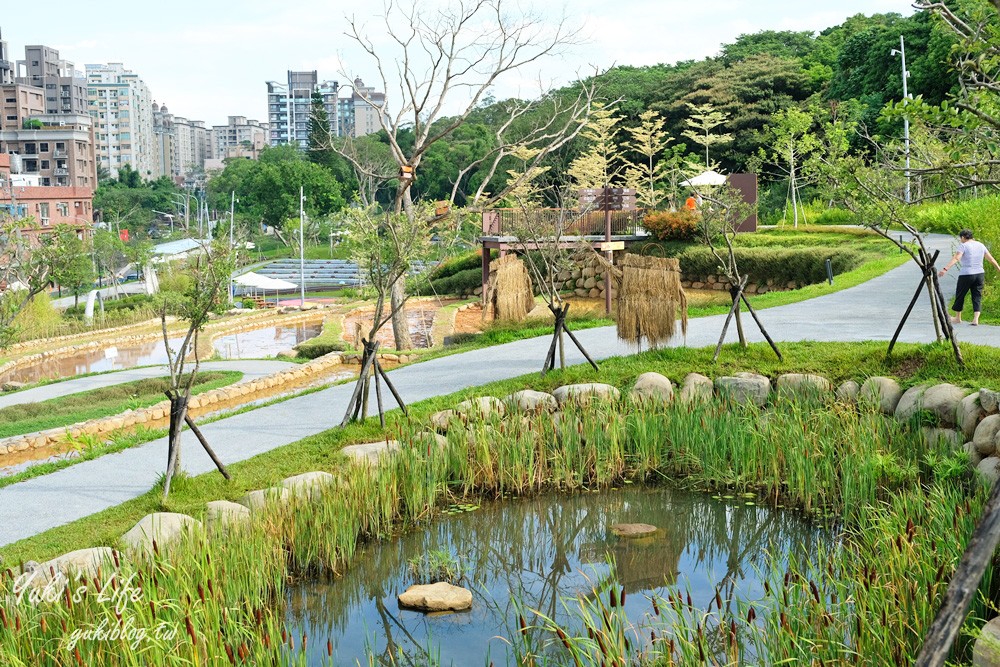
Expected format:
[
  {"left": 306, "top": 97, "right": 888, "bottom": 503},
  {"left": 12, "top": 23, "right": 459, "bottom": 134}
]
[{"left": 0, "top": 371, "right": 243, "bottom": 438}]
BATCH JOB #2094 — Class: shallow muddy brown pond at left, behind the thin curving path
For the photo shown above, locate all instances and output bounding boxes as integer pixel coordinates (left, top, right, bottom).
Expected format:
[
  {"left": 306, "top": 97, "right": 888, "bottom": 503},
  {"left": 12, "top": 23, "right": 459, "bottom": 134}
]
[{"left": 0, "top": 322, "right": 323, "bottom": 384}]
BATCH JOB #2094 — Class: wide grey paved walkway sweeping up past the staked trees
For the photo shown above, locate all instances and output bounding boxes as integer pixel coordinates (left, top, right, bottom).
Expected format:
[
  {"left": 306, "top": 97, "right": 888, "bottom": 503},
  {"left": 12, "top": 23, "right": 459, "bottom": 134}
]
[{"left": 0, "top": 236, "right": 1000, "bottom": 547}]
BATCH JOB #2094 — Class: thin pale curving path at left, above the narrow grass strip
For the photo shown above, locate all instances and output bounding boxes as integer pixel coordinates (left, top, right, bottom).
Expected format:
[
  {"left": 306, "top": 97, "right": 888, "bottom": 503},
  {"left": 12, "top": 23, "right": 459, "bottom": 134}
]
[{"left": 0, "top": 359, "right": 298, "bottom": 408}]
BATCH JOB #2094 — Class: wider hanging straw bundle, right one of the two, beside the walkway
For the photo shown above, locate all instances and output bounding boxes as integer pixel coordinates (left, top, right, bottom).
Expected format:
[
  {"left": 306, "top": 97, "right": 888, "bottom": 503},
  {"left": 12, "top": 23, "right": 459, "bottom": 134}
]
[{"left": 618, "top": 254, "right": 687, "bottom": 348}]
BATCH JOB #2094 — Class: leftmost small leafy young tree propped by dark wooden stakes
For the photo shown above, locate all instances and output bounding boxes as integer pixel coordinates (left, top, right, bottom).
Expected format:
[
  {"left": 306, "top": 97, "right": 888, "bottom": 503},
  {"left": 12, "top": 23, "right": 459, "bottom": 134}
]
[{"left": 160, "top": 239, "right": 237, "bottom": 500}]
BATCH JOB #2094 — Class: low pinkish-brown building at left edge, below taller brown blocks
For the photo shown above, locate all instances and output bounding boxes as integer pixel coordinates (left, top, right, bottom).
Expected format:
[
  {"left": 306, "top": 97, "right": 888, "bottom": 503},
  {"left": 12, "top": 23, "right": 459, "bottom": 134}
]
[{"left": 0, "top": 153, "right": 94, "bottom": 243}]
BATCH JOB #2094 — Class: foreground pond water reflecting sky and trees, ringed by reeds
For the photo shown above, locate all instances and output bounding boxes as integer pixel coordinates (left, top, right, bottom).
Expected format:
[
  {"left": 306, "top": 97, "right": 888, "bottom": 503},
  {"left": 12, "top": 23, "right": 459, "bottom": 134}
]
[{"left": 286, "top": 487, "right": 835, "bottom": 665}]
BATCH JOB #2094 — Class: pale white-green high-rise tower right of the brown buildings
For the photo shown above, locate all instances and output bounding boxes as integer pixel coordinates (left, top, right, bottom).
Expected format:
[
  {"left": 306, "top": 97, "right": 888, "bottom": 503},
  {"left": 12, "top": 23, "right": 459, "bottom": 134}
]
[{"left": 87, "top": 63, "right": 157, "bottom": 178}]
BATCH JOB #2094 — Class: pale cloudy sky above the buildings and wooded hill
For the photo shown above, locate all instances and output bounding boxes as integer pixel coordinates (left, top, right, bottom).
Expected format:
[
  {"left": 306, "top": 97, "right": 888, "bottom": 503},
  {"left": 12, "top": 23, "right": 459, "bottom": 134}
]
[{"left": 0, "top": 0, "right": 913, "bottom": 125}]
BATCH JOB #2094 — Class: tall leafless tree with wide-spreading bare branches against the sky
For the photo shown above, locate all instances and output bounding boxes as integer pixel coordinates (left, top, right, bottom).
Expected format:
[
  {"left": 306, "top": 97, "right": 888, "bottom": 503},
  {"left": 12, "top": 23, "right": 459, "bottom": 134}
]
[{"left": 324, "top": 0, "right": 589, "bottom": 349}]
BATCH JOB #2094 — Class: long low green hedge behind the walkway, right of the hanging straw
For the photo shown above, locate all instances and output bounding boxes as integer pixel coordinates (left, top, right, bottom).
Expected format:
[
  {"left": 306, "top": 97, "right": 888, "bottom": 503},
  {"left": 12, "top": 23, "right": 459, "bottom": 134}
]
[{"left": 677, "top": 246, "right": 871, "bottom": 285}]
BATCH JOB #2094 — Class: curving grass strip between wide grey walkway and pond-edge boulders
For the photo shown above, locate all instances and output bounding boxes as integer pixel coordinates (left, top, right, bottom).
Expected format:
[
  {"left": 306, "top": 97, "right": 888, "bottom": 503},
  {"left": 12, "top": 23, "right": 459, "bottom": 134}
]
[{"left": 0, "top": 342, "right": 1000, "bottom": 565}]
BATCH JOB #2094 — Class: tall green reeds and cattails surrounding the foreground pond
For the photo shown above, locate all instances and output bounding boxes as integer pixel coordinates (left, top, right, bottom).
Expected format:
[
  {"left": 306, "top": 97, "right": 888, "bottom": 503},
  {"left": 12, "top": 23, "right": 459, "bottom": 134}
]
[{"left": 0, "top": 388, "right": 993, "bottom": 667}]
